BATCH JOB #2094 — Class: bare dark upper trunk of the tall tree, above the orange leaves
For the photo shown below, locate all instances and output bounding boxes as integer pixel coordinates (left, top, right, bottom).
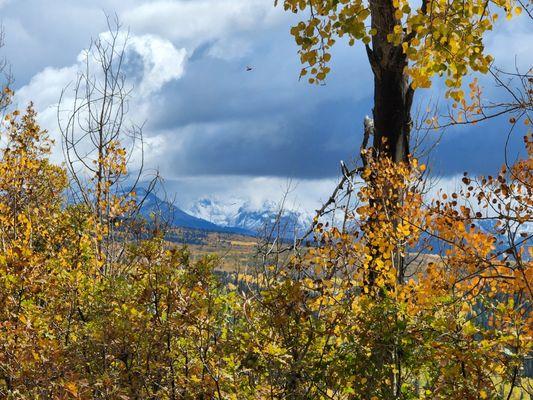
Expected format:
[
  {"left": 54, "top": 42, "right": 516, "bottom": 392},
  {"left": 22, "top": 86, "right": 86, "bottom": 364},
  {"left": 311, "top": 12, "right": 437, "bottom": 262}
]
[{"left": 366, "top": 0, "right": 414, "bottom": 162}]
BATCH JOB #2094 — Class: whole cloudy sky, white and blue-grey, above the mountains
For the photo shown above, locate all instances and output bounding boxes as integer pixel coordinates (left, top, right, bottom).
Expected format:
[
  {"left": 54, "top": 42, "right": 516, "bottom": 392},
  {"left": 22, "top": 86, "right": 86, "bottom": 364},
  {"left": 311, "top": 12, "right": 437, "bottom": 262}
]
[{"left": 0, "top": 0, "right": 533, "bottom": 209}]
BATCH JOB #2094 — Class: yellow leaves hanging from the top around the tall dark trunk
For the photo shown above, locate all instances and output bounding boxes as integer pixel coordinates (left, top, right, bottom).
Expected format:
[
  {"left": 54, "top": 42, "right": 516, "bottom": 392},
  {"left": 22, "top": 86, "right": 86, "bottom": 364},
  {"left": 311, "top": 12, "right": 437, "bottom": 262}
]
[{"left": 283, "top": 0, "right": 522, "bottom": 101}]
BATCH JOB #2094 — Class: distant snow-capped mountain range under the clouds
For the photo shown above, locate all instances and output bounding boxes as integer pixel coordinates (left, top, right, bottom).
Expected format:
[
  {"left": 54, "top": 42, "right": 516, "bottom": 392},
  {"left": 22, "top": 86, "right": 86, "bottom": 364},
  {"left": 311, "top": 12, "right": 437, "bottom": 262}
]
[{"left": 187, "top": 198, "right": 312, "bottom": 238}]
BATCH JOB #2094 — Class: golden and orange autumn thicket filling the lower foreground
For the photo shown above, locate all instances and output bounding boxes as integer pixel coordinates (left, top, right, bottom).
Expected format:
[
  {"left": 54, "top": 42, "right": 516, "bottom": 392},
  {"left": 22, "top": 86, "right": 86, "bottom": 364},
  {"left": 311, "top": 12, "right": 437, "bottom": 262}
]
[{"left": 0, "top": 97, "right": 533, "bottom": 400}]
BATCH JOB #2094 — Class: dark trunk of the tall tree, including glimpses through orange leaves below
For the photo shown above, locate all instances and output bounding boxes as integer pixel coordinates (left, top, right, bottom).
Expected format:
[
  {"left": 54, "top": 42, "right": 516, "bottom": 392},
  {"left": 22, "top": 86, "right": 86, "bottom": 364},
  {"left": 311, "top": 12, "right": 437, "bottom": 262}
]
[{"left": 366, "top": 6, "right": 412, "bottom": 392}]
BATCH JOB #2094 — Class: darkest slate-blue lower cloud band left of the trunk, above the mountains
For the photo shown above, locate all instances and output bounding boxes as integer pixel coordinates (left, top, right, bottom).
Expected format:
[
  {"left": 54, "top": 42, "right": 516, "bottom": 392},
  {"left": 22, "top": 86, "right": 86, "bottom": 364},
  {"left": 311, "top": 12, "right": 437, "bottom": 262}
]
[{"left": 151, "top": 97, "right": 360, "bottom": 178}]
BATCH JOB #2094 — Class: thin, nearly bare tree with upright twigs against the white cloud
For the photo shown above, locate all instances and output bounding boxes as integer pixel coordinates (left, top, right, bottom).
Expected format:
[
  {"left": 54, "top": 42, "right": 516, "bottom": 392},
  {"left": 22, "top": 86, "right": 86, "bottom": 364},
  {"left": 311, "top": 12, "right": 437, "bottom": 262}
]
[{"left": 58, "top": 18, "right": 158, "bottom": 271}]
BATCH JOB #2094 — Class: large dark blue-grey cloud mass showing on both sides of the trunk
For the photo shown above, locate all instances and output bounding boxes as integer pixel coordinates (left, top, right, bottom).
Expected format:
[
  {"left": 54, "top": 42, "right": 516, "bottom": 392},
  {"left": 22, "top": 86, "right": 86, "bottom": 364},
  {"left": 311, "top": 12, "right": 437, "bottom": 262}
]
[{"left": 139, "top": 25, "right": 521, "bottom": 178}]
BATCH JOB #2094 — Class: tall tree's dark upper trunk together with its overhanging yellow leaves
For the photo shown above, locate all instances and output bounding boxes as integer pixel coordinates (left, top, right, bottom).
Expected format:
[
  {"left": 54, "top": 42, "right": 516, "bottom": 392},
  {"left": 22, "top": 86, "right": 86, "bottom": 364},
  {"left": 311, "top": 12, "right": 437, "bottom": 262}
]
[{"left": 276, "top": 0, "right": 522, "bottom": 162}]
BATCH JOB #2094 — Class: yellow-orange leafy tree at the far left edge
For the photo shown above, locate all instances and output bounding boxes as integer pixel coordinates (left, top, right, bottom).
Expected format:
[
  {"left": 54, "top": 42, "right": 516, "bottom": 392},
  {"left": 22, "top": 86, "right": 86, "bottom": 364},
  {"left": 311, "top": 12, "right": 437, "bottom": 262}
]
[{"left": 0, "top": 105, "right": 72, "bottom": 398}]
